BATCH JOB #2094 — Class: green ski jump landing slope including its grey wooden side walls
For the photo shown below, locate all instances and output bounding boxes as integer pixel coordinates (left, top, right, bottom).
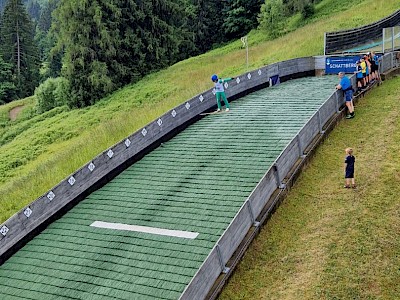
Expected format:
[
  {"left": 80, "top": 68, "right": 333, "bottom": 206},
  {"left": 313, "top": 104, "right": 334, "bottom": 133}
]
[{"left": 0, "top": 19, "right": 394, "bottom": 300}]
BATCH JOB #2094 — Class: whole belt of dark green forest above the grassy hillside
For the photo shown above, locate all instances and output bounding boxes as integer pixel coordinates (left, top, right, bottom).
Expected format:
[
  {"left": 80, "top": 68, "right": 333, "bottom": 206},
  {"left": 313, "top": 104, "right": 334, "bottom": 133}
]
[{"left": 0, "top": 0, "right": 321, "bottom": 108}]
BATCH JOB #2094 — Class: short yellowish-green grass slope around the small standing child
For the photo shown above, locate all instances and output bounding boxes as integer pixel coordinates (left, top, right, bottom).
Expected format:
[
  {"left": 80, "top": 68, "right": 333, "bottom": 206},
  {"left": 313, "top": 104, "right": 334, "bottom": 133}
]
[{"left": 220, "top": 77, "right": 400, "bottom": 300}]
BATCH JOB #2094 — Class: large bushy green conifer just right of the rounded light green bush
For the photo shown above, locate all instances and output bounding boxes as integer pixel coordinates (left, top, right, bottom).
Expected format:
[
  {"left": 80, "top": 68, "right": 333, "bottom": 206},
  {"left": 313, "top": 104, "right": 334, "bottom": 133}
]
[{"left": 55, "top": 0, "right": 120, "bottom": 107}]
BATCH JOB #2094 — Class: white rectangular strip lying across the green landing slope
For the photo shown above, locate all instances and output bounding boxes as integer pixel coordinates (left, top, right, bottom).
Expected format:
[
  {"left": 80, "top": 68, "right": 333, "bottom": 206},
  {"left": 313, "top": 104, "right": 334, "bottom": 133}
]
[{"left": 90, "top": 221, "right": 199, "bottom": 240}]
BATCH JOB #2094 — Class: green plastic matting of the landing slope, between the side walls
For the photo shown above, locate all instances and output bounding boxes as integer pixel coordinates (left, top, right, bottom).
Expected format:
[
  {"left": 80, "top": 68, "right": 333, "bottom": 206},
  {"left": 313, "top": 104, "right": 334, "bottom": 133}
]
[{"left": 0, "top": 76, "right": 338, "bottom": 300}]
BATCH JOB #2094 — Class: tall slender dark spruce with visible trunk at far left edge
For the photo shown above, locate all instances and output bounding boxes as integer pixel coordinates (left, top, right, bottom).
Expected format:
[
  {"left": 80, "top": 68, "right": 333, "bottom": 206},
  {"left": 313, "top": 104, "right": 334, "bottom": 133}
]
[{"left": 0, "top": 0, "right": 39, "bottom": 98}]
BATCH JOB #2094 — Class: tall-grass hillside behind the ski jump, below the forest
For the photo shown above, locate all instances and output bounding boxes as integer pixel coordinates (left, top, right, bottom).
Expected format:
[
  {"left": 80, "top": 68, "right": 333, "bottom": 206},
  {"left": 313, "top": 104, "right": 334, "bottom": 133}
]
[{"left": 0, "top": 0, "right": 398, "bottom": 222}]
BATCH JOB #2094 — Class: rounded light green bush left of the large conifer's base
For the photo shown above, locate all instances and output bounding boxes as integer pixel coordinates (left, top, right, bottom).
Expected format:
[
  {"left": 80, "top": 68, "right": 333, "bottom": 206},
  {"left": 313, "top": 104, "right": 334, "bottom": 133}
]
[{"left": 35, "top": 77, "right": 70, "bottom": 113}]
